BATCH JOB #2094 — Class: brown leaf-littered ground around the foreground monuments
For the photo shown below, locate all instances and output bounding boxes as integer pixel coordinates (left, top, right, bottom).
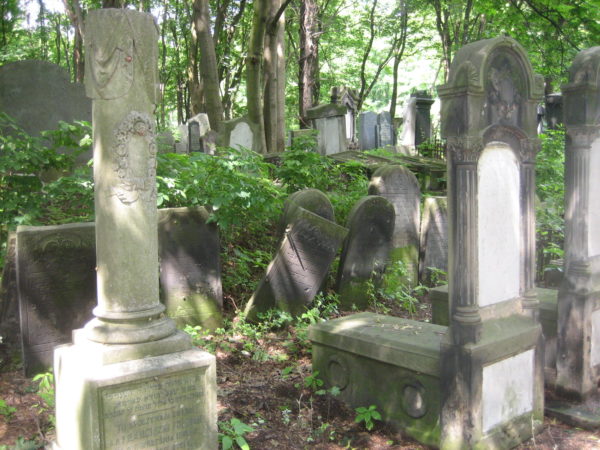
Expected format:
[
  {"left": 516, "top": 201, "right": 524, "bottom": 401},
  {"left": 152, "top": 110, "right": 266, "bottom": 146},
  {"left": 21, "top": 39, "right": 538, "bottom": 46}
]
[{"left": 0, "top": 298, "right": 600, "bottom": 450}]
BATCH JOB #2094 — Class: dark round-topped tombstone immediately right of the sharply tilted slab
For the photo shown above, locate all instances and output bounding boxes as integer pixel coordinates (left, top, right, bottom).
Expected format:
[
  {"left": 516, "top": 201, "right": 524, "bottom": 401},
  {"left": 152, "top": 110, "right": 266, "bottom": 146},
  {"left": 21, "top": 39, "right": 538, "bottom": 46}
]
[{"left": 336, "top": 195, "right": 395, "bottom": 310}]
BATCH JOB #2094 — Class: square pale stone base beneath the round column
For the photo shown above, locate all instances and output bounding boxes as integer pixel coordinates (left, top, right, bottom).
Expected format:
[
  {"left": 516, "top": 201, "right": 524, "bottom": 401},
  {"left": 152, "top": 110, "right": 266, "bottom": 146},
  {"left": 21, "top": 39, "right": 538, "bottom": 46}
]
[{"left": 54, "top": 330, "right": 217, "bottom": 450}]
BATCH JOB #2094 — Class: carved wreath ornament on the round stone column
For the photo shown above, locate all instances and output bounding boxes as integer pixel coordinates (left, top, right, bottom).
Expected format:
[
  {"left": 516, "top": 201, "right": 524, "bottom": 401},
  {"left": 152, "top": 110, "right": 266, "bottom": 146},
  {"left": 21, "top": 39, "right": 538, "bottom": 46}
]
[{"left": 113, "top": 111, "right": 156, "bottom": 205}]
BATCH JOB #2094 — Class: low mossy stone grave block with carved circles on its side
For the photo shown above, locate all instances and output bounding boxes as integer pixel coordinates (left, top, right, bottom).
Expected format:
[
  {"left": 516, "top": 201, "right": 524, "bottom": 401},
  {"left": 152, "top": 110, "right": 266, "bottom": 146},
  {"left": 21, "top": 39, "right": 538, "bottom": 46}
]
[{"left": 309, "top": 313, "right": 447, "bottom": 446}]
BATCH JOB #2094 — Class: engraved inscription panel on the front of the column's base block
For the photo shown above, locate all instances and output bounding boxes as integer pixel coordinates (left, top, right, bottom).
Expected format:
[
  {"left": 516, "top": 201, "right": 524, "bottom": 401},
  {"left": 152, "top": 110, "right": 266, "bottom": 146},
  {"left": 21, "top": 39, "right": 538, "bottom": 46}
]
[{"left": 99, "top": 370, "right": 204, "bottom": 450}]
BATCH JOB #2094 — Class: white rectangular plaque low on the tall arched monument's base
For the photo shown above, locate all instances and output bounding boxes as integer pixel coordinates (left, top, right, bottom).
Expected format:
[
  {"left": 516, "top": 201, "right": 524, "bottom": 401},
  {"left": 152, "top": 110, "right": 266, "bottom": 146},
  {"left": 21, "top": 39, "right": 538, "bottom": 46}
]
[{"left": 482, "top": 349, "right": 534, "bottom": 432}]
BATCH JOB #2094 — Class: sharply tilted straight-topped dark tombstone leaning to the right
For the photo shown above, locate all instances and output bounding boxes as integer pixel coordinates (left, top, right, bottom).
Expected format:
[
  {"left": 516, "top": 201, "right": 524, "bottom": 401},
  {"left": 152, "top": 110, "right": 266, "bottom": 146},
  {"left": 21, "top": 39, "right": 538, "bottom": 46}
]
[{"left": 245, "top": 208, "right": 347, "bottom": 321}]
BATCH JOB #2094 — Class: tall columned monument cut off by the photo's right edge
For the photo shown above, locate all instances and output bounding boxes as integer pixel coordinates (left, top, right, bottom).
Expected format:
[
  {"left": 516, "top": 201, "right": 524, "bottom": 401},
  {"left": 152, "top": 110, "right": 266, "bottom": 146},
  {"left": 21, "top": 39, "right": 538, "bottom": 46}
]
[{"left": 551, "top": 47, "right": 600, "bottom": 418}]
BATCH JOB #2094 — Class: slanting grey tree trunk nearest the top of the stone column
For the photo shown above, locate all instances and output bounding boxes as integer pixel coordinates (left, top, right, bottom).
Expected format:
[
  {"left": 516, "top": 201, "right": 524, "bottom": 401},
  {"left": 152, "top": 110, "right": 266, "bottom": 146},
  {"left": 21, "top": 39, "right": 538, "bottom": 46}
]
[{"left": 192, "top": 0, "right": 223, "bottom": 131}]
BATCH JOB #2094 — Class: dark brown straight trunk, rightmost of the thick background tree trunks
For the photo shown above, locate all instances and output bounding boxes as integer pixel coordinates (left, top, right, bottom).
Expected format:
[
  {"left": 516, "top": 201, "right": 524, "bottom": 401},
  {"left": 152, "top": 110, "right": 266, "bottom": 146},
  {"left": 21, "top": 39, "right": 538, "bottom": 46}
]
[{"left": 298, "top": 0, "right": 319, "bottom": 128}]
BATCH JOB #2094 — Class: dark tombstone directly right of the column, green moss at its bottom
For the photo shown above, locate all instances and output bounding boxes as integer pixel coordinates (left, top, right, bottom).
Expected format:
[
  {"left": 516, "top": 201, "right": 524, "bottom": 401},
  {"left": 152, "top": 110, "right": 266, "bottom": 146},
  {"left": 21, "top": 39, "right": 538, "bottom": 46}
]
[{"left": 158, "top": 207, "right": 223, "bottom": 330}]
